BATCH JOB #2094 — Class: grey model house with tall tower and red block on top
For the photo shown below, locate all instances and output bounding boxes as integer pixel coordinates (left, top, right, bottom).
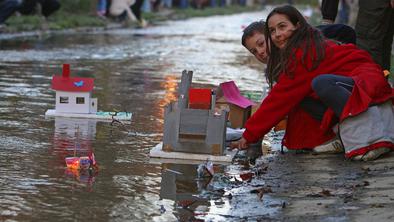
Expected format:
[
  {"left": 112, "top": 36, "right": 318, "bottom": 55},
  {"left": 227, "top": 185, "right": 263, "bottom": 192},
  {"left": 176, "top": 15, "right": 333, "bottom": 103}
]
[{"left": 162, "top": 70, "right": 227, "bottom": 155}]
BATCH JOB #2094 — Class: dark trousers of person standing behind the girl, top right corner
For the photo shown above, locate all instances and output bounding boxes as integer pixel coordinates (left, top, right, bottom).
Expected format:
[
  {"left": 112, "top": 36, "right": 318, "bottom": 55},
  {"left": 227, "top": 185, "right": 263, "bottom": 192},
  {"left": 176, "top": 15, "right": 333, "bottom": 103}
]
[{"left": 355, "top": 0, "right": 394, "bottom": 70}]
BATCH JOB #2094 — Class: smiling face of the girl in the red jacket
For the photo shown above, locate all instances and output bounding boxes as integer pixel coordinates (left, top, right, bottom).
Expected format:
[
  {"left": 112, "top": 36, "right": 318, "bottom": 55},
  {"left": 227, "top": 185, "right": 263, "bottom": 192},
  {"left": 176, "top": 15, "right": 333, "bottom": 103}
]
[{"left": 268, "top": 14, "right": 298, "bottom": 49}]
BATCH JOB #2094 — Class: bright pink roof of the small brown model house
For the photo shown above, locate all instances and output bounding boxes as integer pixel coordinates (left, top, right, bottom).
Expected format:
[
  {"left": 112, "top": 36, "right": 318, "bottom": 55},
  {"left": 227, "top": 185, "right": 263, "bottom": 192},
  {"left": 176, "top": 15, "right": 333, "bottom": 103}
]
[{"left": 220, "top": 81, "right": 254, "bottom": 108}]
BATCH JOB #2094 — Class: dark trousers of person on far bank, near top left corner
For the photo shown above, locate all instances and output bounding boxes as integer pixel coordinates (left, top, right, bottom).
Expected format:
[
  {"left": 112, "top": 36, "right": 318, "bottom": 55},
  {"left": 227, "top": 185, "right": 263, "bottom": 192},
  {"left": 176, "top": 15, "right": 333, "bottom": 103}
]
[{"left": 19, "top": 0, "right": 60, "bottom": 17}]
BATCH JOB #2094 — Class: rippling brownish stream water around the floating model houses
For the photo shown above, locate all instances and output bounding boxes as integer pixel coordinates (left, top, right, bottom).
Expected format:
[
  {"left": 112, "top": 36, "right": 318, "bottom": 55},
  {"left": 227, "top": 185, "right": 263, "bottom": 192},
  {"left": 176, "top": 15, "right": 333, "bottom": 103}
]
[{"left": 0, "top": 12, "right": 280, "bottom": 221}]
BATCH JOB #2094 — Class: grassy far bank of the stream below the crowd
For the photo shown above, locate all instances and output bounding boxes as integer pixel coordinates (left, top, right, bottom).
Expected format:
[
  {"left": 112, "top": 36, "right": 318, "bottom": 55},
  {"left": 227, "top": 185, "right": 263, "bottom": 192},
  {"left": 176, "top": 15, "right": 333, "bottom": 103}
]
[{"left": 0, "top": 5, "right": 262, "bottom": 34}]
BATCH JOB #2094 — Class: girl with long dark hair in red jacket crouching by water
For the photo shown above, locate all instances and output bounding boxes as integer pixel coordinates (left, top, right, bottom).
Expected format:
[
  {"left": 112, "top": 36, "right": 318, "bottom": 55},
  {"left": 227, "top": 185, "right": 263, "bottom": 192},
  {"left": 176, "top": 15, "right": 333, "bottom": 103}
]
[{"left": 235, "top": 6, "right": 394, "bottom": 160}]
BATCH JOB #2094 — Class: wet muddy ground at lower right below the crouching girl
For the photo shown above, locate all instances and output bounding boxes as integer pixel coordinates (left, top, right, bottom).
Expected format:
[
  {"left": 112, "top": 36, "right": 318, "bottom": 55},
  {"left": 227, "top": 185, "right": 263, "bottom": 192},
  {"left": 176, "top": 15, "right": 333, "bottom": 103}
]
[{"left": 262, "top": 150, "right": 394, "bottom": 221}]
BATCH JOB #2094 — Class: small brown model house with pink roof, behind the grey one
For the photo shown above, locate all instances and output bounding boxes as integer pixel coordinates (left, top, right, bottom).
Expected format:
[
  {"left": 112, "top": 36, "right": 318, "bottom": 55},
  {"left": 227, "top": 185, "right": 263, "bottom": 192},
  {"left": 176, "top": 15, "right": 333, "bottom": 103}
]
[{"left": 216, "top": 81, "right": 254, "bottom": 128}]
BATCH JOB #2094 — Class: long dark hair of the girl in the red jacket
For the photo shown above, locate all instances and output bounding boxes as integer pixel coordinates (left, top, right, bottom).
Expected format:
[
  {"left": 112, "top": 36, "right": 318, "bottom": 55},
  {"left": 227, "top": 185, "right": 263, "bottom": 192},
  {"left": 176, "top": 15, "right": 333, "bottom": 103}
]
[{"left": 265, "top": 5, "right": 326, "bottom": 88}]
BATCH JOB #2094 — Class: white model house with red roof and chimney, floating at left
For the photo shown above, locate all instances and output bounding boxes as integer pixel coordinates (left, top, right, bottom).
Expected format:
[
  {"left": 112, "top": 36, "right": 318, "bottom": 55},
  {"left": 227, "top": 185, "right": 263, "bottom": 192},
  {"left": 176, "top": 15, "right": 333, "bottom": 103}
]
[{"left": 52, "top": 64, "right": 97, "bottom": 114}]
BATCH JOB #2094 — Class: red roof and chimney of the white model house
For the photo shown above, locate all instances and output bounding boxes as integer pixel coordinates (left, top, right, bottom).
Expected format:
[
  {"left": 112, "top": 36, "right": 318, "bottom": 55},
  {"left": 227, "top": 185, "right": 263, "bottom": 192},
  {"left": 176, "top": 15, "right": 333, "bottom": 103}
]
[{"left": 52, "top": 64, "right": 94, "bottom": 92}]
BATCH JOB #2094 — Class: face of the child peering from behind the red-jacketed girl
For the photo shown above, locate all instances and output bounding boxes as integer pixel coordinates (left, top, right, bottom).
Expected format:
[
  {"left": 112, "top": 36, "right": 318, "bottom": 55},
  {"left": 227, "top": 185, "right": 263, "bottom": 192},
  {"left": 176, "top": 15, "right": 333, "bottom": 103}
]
[{"left": 245, "top": 32, "right": 268, "bottom": 64}]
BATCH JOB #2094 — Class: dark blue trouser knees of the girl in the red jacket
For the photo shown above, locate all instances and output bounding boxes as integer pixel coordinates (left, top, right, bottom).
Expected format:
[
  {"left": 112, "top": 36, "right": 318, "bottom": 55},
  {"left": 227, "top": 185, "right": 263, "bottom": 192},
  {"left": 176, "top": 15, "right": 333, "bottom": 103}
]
[{"left": 300, "top": 74, "right": 354, "bottom": 121}]
